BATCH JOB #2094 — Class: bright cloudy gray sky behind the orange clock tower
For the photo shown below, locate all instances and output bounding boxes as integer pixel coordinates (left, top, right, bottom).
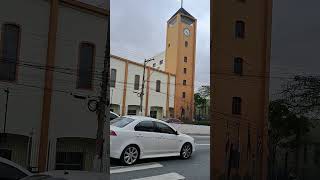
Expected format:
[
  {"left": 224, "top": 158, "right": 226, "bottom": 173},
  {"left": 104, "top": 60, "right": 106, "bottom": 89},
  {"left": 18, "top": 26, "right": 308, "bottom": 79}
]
[{"left": 110, "top": 0, "right": 210, "bottom": 90}]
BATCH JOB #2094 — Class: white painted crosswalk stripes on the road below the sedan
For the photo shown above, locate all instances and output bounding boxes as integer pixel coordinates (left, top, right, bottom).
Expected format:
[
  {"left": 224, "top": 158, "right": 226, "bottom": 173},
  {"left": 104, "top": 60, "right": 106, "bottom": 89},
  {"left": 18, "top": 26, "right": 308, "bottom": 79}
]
[{"left": 110, "top": 163, "right": 185, "bottom": 180}]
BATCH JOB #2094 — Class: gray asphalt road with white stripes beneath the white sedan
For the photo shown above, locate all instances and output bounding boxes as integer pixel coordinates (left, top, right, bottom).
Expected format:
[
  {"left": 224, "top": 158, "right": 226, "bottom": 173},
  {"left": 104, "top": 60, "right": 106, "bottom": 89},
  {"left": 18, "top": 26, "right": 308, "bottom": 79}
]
[{"left": 110, "top": 136, "right": 210, "bottom": 180}]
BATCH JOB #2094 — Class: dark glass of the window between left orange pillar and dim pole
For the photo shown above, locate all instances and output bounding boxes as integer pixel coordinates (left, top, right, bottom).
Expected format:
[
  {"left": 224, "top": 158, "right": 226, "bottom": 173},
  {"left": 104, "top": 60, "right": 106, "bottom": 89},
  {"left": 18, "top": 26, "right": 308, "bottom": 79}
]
[{"left": 77, "top": 43, "right": 95, "bottom": 89}]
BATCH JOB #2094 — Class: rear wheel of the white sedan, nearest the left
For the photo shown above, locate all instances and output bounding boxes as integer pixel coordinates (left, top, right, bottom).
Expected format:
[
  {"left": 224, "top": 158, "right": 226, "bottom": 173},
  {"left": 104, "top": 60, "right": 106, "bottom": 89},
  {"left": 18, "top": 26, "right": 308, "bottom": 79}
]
[{"left": 120, "top": 145, "right": 140, "bottom": 166}]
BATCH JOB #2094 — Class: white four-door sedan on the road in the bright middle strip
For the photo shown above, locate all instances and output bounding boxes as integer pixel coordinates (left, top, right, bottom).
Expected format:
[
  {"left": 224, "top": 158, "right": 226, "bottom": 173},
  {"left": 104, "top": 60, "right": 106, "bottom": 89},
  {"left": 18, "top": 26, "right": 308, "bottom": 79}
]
[{"left": 110, "top": 116, "right": 195, "bottom": 165}]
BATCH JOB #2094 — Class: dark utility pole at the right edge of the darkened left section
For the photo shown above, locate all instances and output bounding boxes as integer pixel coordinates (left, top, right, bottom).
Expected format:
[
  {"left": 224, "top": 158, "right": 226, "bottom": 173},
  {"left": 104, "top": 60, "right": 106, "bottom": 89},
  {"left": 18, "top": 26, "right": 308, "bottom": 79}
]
[{"left": 95, "top": 16, "right": 110, "bottom": 172}]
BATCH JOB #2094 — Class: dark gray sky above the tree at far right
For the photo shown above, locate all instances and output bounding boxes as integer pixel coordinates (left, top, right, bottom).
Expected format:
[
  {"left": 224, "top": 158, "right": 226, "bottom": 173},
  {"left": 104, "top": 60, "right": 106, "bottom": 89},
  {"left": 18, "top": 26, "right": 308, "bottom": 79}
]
[{"left": 270, "top": 0, "right": 320, "bottom": 97}]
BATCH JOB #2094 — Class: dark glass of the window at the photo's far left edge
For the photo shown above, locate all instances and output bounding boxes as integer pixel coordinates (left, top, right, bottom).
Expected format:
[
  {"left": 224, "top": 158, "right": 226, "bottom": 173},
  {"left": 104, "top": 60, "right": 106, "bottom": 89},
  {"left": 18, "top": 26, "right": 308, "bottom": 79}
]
[{"left": 0, "top": 24, "right": 20, "bottom": 81}]
